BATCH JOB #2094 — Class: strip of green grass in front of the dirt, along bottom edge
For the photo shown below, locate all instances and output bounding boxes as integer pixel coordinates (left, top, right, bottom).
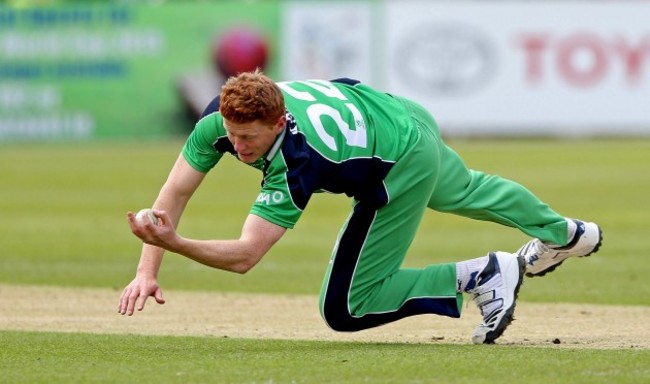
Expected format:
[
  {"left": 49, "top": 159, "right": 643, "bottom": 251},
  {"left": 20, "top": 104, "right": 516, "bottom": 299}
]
[{"left": 0, "top": 332, "right": 650, "bottom": 384}]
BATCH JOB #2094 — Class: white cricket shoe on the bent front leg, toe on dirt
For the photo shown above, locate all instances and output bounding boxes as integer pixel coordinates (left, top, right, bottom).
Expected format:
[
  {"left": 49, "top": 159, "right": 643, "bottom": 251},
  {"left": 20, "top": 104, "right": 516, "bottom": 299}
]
[{"left": 467, "top": 252, "right": 525, "bottom": 344}]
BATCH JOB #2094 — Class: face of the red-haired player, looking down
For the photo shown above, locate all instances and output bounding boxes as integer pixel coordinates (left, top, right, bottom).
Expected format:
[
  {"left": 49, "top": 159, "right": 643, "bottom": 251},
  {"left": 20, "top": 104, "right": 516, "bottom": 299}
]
[{"left": 223, "top": 116, "right": 285, "bottom": 164}]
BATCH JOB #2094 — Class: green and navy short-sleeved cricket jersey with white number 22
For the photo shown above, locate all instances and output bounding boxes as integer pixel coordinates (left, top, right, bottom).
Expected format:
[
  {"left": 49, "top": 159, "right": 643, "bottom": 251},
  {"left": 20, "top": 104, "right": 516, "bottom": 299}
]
[{"left": 183, "top": 79, "right": 419, "bottom": 228}]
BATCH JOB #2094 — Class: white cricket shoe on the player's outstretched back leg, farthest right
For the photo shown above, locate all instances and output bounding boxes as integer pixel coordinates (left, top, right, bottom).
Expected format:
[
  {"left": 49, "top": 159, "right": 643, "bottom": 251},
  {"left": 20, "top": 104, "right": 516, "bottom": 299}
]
[{"left": 516, "top": 219, "right": 603, "bottom": 277}]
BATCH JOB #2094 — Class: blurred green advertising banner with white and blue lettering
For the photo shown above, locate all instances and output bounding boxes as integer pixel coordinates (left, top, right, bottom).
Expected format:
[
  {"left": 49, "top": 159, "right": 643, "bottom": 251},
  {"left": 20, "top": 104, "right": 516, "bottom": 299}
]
[{"left": 0, "top": 1, "right": 280, "bottom": 142}]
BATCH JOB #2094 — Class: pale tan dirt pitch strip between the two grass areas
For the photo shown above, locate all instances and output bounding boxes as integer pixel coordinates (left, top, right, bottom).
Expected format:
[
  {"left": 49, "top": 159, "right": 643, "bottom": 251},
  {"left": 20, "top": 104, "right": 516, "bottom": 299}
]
[{"left": 0, "top": 285, "right": 650, "bottom": 349}]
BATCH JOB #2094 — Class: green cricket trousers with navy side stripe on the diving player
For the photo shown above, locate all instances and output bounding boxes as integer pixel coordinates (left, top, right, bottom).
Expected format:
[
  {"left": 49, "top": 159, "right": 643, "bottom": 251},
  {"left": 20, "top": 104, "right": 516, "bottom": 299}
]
[{"left": 320, "top": 98, "right": 567, "bottom": 332}]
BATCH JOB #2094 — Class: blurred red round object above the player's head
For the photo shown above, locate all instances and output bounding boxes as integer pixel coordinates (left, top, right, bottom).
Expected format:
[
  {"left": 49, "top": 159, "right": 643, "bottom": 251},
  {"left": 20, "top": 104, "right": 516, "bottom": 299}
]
[{"left": 213, "top": 28, "right": 268, "bottom": 78}]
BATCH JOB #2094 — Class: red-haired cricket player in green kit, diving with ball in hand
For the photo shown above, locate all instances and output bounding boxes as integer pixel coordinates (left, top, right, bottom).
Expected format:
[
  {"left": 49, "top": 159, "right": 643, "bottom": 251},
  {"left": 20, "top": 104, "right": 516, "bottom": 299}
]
[{"left": 118, "top": 71, "right": 601, "bottom": 344}]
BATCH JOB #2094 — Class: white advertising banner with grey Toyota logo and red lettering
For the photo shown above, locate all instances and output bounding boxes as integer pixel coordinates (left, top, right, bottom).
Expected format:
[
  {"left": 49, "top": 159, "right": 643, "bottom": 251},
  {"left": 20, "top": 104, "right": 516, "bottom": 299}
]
[{"left": 384, "top": 1, "right": 650, "bottom": 136}]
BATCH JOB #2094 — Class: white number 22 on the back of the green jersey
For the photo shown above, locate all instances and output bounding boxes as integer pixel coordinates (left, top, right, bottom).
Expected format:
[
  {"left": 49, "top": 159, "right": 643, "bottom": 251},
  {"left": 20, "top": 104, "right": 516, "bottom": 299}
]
[{"left": 278, "top": 80, "right": 368, "bottom": 151}]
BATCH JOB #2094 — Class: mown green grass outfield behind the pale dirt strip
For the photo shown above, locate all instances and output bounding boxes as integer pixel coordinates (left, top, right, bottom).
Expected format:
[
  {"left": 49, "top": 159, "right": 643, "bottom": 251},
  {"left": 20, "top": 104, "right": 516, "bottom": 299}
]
[{"left": 0, "top": 140, "right": 650, "bottom": 305}]
